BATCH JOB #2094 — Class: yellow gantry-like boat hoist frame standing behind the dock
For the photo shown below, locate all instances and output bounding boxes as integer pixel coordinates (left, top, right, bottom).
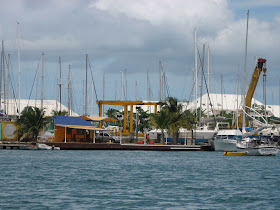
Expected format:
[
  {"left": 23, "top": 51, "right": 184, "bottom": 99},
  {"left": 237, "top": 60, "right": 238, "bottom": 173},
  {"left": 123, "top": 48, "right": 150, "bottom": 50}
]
[{"left": 96, "top": 101, "right": 159, "bottom": 134}]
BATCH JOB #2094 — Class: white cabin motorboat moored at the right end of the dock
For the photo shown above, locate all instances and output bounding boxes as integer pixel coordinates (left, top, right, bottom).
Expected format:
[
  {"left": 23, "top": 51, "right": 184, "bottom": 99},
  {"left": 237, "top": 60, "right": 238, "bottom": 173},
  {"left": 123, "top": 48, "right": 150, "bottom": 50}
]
[{"left": 214, "top": 129, "right": 242, "bottom": 152}]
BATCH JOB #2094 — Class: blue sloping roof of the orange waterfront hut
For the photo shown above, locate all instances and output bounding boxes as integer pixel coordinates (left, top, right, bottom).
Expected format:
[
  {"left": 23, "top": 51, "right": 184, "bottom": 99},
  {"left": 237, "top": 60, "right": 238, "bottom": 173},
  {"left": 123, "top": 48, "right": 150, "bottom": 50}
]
[{"left": 53, "top": 115, "right": 93, "bottom": 127}]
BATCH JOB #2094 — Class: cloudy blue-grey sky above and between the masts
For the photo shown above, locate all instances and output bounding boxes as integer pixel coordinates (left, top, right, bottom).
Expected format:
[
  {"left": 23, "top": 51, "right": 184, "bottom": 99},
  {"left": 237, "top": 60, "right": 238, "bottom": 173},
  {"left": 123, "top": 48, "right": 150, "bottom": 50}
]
[{"left": 0, "top": 0, "right": 280, "bottom": 115}]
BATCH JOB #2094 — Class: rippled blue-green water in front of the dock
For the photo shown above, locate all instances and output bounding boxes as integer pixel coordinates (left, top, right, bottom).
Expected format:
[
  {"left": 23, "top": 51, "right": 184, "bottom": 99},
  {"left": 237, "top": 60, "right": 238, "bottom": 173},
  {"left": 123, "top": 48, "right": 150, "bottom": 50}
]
[{"left": 0, "top": 150, "right": 280, "bottom": 209}]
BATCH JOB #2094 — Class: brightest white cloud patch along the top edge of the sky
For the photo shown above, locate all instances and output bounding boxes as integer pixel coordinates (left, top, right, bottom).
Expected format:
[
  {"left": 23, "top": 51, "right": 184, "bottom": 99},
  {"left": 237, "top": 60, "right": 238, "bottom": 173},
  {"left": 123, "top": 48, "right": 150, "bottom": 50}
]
[{"left": 90, "top": 0, "right": 232, "bottom": 28}]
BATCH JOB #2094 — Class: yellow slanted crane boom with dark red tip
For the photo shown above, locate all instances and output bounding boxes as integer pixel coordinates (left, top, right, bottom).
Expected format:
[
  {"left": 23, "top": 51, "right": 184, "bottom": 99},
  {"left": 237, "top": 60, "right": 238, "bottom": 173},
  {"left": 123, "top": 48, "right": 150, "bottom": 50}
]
[{"left": 238, "top": 58, "right": 267, "bottom": 127}]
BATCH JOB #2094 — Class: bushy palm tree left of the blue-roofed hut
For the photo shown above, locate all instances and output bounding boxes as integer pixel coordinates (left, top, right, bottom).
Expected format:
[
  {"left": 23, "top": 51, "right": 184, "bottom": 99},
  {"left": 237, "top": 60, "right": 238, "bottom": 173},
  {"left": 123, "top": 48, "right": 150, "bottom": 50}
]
[{"left": 16, "top": 106, "right": 48, "bottom": 141}]
